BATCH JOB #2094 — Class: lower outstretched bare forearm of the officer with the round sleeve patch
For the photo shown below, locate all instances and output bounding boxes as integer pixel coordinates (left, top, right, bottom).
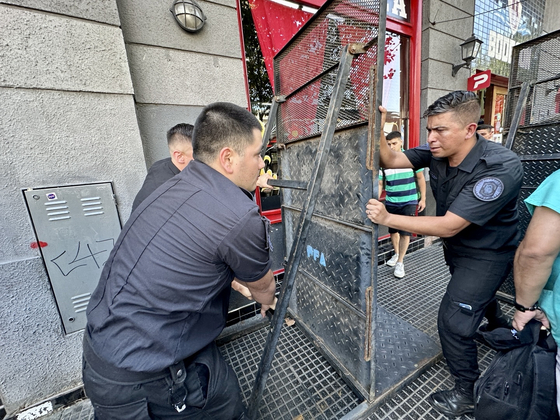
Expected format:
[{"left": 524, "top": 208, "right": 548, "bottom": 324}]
[{"left": 366, "top": 202, "right": 471, "bottom": 238}]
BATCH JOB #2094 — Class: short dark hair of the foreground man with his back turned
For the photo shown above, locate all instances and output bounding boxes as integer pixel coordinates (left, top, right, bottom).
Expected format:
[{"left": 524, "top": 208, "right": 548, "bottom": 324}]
[{"left": 193, "top": 102, "right": 262, "bottom": 163}]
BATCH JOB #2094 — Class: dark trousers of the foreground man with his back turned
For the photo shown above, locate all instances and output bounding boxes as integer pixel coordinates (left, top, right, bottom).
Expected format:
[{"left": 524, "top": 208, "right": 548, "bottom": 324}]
[{"left": 82, "top": 340, "right": 245, "bottom": 420}]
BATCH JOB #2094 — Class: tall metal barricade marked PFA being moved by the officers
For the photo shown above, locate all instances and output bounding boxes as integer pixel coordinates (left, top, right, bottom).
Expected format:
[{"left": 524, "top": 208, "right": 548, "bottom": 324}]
[{"left": 249, "top": 0, "right": 439, "bottom": 413}]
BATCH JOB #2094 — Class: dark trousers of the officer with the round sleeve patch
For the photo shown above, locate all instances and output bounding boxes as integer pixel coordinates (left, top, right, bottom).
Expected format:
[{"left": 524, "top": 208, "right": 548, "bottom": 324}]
[{"left": 438, "top": 246, "right": 514, "bottom": 392}]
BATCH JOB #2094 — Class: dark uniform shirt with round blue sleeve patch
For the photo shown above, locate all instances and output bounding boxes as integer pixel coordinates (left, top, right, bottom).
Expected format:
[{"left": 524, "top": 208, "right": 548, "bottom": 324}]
[{"left": 404, "top": 135, "right": 523, "bottom": 255}]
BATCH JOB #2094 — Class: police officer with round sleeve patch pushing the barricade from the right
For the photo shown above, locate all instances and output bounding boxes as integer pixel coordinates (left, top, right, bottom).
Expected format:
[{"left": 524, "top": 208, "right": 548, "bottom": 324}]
[{"left": 366, "top": 91, "right": 523, "bottom": 416}]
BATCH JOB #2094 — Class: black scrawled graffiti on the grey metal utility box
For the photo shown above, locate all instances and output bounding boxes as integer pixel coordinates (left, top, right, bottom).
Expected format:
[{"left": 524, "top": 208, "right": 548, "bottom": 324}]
[{"left": 50, "top": 238, "right": 115, "bottom": 277}]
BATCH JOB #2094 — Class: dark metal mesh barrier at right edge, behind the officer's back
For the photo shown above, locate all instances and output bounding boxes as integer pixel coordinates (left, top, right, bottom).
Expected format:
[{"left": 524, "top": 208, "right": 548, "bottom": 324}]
[{"left": 500, "top": 31, "right": 560, "bottom": 296}]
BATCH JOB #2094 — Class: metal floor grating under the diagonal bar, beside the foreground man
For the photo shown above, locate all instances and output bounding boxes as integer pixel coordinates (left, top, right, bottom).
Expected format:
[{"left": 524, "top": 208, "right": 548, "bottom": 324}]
[{"left": 221, "top": 326, "right": 360, "bottom": 420}]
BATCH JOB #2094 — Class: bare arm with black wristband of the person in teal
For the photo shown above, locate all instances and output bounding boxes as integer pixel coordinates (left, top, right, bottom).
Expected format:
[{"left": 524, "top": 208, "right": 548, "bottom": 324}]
[{"left": 513, "top": 207, "right": 560, "bottom": 330}]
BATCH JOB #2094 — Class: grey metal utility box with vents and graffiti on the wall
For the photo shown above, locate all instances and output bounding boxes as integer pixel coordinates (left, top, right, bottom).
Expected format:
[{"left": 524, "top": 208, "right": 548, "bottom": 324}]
[{"left": 23, "top": 182, "right": 121, "bottom": 334}]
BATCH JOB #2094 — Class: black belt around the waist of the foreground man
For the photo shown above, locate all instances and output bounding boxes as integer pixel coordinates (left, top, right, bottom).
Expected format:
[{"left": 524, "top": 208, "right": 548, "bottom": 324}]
[{"left": 84, "top": 332, "right": 186, "bottom": 382}]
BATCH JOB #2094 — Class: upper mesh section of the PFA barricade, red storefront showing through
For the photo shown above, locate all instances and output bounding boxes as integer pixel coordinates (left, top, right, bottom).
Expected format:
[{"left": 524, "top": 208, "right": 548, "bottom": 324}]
[{"left": 274, "top": 0, "right": 380, "bottom": 143}]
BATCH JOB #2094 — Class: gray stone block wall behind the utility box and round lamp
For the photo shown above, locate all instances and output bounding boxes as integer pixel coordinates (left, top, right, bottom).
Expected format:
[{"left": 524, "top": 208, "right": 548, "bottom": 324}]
[{"left": 0, "top": 0, "right": 247, "bottom": 415}]
